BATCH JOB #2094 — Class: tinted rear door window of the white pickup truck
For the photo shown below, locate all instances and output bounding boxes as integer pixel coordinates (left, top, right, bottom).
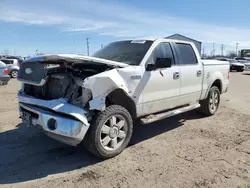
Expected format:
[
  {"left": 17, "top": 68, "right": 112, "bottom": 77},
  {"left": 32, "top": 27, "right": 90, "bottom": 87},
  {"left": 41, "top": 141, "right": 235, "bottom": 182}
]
[{"left": 176, "top": 43, "right": 198, "bottom": 65}]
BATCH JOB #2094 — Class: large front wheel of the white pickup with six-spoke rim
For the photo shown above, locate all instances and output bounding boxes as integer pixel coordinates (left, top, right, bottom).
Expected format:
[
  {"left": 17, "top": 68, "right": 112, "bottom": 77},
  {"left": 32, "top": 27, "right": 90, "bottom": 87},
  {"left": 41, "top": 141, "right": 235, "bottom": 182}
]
[{"left": 83, "top": 105, "right": 133, "bottom": 159}]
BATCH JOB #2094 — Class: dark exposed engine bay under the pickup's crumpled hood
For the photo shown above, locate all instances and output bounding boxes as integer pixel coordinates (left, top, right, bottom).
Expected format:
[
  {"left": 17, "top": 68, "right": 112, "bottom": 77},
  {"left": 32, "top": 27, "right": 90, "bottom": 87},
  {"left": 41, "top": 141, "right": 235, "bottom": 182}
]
[{"left": 23, "top": 62, "right": 113, "bottom": 108}]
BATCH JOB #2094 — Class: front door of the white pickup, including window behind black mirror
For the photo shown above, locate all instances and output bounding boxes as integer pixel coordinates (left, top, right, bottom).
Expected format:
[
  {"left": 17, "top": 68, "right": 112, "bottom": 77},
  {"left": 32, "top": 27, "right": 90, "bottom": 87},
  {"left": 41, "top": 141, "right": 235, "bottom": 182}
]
[{"left": 141, "top": 42, "right": 180, "bottom": 115}]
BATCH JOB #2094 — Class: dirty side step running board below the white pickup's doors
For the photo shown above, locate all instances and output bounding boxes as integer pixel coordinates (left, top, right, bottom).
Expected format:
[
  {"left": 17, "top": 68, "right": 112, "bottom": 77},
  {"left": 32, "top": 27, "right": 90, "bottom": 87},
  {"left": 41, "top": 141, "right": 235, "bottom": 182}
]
[{"left": 141, "top": 103, "right": 200, "bottom": 124}]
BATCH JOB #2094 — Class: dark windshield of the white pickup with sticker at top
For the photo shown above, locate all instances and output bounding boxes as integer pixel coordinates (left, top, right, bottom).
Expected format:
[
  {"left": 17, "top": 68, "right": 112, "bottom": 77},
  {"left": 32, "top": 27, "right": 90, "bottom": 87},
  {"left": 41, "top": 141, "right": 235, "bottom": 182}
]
[{"left": 93, "top": 40, "right": 153, "bottom": 65}]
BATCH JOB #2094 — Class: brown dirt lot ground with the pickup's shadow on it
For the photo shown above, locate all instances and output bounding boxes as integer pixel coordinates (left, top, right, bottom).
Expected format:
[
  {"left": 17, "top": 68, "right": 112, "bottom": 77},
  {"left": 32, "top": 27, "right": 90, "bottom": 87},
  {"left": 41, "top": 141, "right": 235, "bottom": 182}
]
[{"left": 0, "top": 73, "right": 250, "bottom": 188}]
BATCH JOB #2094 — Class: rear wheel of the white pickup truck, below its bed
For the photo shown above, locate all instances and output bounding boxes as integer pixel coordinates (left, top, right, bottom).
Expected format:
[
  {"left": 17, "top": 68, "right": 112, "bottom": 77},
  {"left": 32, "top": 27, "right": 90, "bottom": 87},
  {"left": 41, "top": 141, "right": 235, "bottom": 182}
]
[{"left": 199, "top": 86, "right": 220, "bottom": 116}]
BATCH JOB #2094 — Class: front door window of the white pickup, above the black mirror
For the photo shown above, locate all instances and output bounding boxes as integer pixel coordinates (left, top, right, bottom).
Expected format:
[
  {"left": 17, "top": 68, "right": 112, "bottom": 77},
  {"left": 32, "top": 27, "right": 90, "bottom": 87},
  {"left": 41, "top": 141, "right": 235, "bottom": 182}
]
[{"left": 154, "top": 42, "right": 174, "bottom": 64}]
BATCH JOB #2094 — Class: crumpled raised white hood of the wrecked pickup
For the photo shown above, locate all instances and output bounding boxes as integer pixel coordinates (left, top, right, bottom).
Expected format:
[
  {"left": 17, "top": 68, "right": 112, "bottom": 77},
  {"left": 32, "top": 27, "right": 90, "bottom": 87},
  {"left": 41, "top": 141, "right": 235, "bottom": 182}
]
[{"left": 23, "top": 54, "right": 128, "bottom": 67}]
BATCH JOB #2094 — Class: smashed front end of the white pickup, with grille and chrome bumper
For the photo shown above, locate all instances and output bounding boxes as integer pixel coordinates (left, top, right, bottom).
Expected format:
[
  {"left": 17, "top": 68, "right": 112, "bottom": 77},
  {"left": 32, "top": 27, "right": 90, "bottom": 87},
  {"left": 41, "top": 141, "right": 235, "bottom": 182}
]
[{"left": 18, "top": 56, "right": 124, "bottom": 146}]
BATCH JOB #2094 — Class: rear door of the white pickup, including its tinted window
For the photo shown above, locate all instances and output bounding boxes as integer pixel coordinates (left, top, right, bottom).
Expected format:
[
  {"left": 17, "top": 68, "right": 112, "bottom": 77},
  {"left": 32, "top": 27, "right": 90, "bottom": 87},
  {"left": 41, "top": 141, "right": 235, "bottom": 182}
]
[{"left": 174, "top": 42, "right": 203, "bottom": 105}]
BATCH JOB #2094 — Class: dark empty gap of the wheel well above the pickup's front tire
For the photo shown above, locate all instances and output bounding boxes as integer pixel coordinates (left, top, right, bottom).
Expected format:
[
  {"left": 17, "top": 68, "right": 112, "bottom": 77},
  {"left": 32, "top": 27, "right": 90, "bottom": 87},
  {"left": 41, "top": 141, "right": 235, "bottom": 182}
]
[{"left": 106, "top": 89, "right": 136, "bottom": 118}]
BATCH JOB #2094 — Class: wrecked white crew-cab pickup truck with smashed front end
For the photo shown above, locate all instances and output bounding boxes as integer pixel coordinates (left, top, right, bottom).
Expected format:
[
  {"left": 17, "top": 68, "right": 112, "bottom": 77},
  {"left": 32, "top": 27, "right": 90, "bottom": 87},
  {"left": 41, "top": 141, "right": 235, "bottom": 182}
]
[{"left": 18, "top": 39, "right": 230, "bottom": 158}]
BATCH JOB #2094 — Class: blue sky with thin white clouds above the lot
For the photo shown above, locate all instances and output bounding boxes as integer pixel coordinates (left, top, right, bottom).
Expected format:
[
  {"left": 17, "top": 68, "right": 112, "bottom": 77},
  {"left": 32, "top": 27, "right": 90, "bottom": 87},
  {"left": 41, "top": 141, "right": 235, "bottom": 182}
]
[{"left": 0, "top": 0, "right": 250, "bottom": 56}]
